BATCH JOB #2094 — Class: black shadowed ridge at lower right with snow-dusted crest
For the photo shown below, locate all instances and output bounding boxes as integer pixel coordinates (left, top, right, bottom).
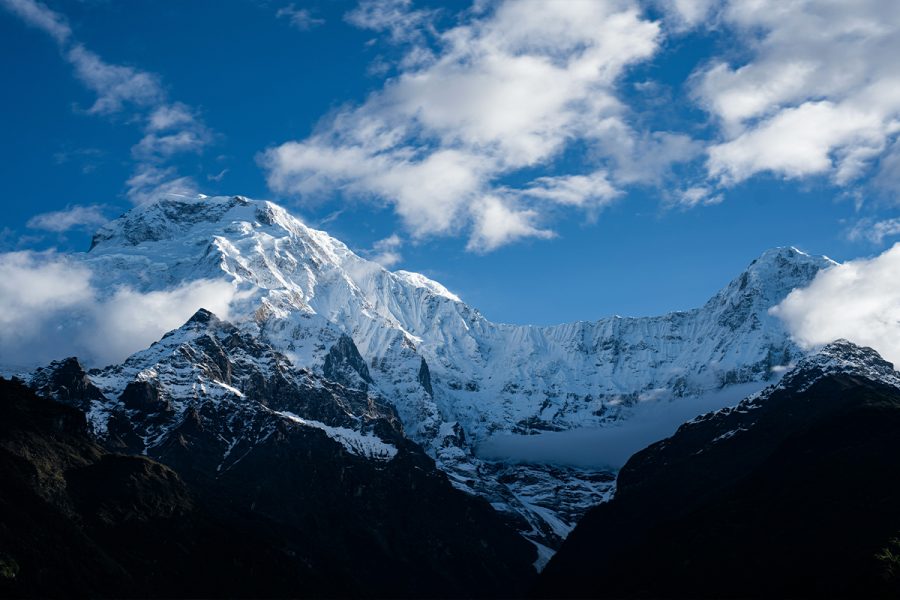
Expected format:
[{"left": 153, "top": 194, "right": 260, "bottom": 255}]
[{"left": 538, "top": 341, "right": 900, "bottom": 597}]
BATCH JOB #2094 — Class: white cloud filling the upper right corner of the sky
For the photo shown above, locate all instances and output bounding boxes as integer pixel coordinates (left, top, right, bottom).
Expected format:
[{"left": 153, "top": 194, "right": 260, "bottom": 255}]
[{"left": 700, "top": 0, "right": 900, "bottom": 185}]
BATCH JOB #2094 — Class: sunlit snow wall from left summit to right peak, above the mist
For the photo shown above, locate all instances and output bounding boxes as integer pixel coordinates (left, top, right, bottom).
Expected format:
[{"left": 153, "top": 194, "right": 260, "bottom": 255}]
[{"left": 86, "top": 197, "right": 833, "bottom": 450}]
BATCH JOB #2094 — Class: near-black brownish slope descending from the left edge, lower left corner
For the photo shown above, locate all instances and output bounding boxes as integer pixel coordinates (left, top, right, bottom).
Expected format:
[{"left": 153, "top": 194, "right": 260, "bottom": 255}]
[{"left": 0, "top": 379, "right": 310, "bottom": 597}]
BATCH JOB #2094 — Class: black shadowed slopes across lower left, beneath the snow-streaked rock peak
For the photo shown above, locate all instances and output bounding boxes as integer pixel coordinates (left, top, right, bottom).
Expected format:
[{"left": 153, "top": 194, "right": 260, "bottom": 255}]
[{"left": 0, "top": 379, "right": 533, "bottom": 597}]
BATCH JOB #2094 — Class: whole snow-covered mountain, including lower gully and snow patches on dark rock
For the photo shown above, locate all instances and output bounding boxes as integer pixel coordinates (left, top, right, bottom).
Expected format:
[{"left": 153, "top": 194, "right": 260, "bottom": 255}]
[{"left": 28, "top": 197, "right": 834, "bottom": 546}]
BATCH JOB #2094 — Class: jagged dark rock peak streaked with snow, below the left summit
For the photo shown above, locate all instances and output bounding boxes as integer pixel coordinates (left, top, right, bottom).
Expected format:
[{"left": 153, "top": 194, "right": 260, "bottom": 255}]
[{"left": 31, "top": 310, "right": 407, "bottom": 472}]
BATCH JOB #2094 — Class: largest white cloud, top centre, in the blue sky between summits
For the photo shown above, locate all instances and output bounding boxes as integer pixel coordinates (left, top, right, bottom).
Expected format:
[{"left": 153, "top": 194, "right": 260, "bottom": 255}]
[{"left": 260, "top": 0, "right": 684, "bottom": 251}]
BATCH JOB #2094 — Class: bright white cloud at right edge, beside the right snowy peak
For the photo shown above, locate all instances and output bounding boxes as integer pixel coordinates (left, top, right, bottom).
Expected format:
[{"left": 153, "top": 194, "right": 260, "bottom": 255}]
[{"left": 771, "top": 244, "right": 900, "bottom": 365}]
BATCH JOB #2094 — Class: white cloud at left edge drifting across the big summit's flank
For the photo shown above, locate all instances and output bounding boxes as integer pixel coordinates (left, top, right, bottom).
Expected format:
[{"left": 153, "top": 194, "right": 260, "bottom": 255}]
[{"left": 0, "top": 252, "right": 236, "bottom": 368}]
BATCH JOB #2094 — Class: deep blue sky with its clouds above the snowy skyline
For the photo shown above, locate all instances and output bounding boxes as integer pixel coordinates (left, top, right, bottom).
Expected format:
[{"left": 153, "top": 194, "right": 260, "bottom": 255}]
[{"left": 0, "top": 0, "right": 900, "bottom": 323}]
